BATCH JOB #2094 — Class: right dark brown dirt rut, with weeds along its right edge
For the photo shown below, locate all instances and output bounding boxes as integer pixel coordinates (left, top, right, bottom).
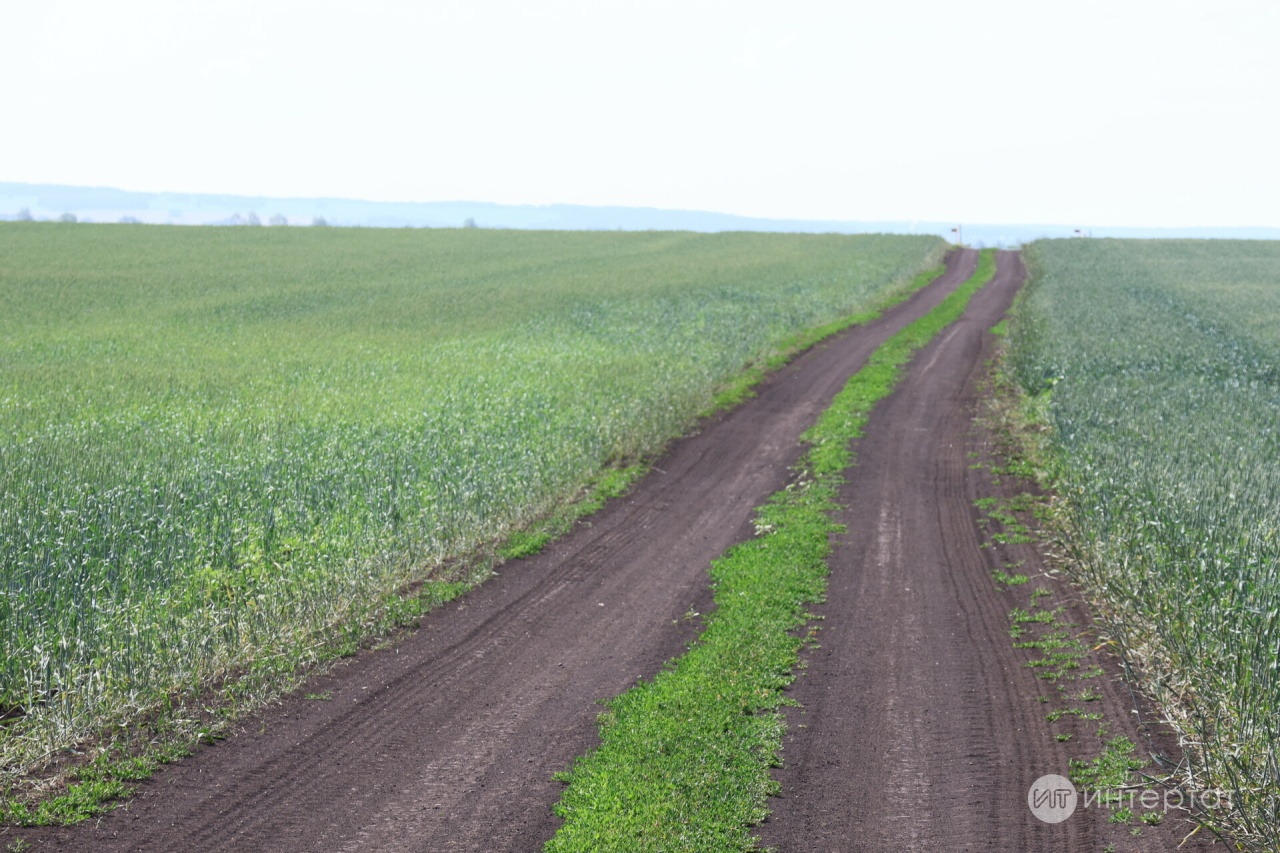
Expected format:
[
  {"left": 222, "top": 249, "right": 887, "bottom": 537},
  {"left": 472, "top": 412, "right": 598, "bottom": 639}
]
[{"left": 760, "top": 252, "right": 1222, "bottom": 853}]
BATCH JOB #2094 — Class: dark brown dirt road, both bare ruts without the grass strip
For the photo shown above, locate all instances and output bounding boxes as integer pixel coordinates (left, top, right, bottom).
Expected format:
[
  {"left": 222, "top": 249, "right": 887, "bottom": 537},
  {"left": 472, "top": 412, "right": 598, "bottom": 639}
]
[{"left": 20, "top": 251, "right": 1208, "bottom": 853}]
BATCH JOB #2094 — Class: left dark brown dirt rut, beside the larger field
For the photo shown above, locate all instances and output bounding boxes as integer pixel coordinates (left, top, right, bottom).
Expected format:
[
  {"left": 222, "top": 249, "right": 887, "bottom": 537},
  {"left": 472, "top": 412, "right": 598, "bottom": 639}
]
[{"left": 15, "top": 250, "right": 977, "bottom": 853}]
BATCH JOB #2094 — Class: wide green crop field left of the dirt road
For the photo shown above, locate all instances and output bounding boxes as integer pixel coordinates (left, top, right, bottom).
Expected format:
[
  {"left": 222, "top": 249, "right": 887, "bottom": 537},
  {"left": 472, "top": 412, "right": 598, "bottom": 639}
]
[{"left": 0, "top": 223, "right": 945, "bottom": 804}]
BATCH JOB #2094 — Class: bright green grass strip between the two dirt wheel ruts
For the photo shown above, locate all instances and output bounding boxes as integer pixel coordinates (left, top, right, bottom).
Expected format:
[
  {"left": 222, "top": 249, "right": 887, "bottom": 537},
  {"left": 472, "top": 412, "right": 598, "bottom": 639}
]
[{"left": 545, "top": 250, "right": 996, "bottom": 853}]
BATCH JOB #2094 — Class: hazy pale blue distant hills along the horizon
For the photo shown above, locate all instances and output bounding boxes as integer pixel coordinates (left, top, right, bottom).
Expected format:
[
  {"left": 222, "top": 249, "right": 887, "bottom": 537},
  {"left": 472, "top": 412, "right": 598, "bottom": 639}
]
[{"left": 0, "top": 182, "right": 1280, "bottom": 246}]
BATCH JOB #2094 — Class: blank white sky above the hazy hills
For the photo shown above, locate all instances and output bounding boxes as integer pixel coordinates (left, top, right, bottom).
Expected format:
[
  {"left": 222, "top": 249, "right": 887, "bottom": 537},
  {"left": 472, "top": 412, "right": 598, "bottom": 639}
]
[{"left": 0, "top": 0, "right": 1280, "bottom": 225}]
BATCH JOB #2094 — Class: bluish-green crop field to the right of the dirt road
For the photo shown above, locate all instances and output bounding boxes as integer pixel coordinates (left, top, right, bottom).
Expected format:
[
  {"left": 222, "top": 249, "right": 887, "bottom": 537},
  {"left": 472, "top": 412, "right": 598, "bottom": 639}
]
[{"left": 1009, "top": 240, "right": 1280, "bottom": 849}]
